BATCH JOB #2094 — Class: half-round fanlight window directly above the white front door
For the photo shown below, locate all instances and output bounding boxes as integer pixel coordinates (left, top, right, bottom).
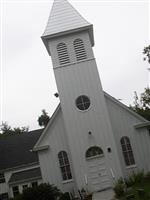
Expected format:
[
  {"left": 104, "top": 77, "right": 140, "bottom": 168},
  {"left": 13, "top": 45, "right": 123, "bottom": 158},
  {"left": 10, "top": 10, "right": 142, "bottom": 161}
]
[{"left": 85, "top": 146, "right": 104, "bottom": 158}]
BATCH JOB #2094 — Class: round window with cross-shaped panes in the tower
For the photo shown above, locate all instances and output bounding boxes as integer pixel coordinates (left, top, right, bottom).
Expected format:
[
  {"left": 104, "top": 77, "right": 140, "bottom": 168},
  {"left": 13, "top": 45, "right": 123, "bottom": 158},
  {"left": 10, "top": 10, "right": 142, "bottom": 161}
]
[{"left": 76, "top": 95, "right": 90, "bottom": 110}]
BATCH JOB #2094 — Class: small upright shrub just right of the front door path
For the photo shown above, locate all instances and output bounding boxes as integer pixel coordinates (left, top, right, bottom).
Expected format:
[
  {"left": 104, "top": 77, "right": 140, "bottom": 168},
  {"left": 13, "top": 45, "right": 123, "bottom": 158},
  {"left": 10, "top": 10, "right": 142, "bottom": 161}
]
[{"left": 113, "top": 178, "right": 126, "bottom": 197}]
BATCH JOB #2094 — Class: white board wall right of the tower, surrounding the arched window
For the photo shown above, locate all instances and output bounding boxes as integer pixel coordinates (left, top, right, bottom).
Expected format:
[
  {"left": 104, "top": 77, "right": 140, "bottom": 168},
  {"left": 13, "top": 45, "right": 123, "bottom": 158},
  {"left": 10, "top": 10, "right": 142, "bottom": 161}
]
[{"left": 105, "top": 95, "right": 150, "bottom": 176}]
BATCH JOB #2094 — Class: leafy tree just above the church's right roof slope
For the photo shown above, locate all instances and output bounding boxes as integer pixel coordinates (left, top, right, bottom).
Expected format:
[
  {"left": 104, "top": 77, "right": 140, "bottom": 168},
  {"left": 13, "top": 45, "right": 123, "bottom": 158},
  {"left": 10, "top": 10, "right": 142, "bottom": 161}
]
[{"left": 130, "top": 88, "right": 150, "bottom": 121}]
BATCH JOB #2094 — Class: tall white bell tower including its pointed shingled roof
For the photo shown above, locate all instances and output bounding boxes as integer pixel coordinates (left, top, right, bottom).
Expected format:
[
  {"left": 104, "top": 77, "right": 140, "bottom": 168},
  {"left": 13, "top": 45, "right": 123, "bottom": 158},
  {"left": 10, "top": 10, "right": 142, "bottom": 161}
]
[{"left": 42, "top": 0, "right": 122, "bottom": 190}]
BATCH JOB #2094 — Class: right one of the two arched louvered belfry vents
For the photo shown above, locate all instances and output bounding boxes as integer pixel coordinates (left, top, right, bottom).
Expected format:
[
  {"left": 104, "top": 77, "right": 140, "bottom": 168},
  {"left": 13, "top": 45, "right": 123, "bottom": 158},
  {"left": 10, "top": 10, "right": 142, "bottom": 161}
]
[{"left": 74, "top": 39, "right": 87, "bottom": 61}]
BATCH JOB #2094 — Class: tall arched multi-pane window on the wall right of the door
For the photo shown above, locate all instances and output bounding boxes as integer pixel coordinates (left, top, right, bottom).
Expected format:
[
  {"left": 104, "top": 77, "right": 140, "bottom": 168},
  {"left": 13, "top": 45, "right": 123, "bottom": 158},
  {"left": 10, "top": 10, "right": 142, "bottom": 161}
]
[{"left": 120, "top": 136, "right": 135, "bottom": 166}]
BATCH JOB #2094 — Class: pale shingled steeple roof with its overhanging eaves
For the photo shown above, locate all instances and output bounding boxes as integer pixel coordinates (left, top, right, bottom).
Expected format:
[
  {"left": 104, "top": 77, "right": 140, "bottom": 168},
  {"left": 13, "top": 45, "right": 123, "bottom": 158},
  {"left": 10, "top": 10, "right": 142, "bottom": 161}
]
[{"left": 42, "top": 0, "right": 94, "bottom": 54}]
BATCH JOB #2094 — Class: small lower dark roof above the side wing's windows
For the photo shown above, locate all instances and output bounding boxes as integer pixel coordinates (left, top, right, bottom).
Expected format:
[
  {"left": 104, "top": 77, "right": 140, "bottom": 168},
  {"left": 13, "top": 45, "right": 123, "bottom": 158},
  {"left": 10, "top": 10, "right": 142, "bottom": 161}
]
[{"left": 9, "top": 167, "right": 41, "bottom": 184}]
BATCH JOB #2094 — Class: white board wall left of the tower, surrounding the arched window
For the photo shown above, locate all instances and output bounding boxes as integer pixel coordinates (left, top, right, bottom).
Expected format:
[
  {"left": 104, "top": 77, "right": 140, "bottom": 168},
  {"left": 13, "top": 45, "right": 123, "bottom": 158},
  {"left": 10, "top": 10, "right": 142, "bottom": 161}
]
[{"left": 38, "top": 109, "right": 74, "bottom": 192}]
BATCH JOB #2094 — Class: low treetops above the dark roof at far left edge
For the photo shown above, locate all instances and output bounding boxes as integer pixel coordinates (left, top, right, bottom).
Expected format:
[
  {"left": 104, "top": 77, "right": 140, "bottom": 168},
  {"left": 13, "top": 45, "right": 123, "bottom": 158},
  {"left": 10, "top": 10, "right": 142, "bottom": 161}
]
[{"left": 1, "top": 122, "right": 29, "bottom": 135}]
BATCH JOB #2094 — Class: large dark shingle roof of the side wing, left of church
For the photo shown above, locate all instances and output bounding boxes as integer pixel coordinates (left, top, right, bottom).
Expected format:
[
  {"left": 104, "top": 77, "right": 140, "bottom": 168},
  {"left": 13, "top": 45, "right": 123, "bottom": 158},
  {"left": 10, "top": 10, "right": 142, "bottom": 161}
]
[{"left": 0, "top": 129, "right": 43, "bottom": 170}]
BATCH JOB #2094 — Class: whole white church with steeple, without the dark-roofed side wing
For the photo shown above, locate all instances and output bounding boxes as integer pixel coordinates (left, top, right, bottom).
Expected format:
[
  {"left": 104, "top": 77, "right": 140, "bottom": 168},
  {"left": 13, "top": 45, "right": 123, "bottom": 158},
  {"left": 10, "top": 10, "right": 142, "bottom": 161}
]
[{"left": 33, "top": 0, "right": 150, "bottom": 197}]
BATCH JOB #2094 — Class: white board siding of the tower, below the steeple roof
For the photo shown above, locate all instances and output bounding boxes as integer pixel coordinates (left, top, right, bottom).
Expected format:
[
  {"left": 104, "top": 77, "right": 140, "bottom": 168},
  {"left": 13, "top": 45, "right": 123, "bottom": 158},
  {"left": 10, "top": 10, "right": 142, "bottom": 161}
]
[{"left": 49, "top": 31, "right": 122, "bottom": 187}]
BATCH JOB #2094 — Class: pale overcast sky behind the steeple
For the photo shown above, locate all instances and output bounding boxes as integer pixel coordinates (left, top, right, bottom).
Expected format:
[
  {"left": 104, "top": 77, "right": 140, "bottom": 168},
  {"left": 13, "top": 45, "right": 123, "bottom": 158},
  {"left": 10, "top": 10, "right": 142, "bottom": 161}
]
[{"left": 0, "top": 0, "right": 150, "bottom": 130}]
